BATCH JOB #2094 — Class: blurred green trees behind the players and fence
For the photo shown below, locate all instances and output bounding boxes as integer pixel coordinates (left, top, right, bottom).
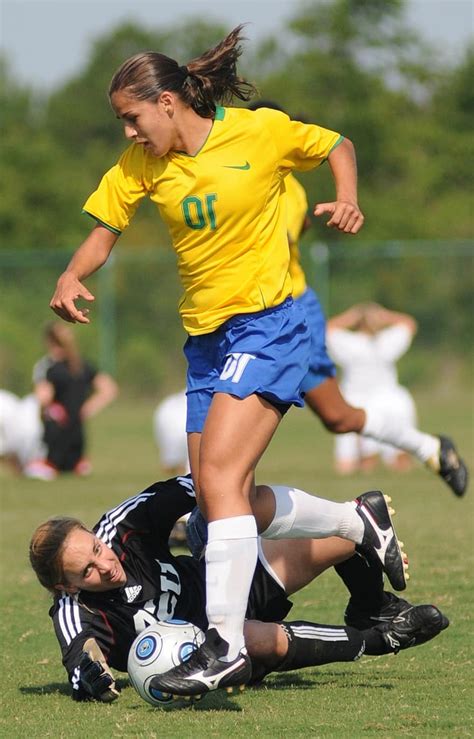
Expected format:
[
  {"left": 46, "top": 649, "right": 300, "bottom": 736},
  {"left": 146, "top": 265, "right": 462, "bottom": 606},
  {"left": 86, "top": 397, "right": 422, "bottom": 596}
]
[{"left": 0, "top": 0, "right": 474, "bottom": 389}]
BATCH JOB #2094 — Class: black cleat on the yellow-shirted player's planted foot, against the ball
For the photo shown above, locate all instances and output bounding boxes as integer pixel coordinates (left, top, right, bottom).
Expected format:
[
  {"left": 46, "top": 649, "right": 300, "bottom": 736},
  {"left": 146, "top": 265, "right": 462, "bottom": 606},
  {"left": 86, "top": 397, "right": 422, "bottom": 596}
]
[{"left": 150, "top": 629, "right": 252, "bottom": 695}]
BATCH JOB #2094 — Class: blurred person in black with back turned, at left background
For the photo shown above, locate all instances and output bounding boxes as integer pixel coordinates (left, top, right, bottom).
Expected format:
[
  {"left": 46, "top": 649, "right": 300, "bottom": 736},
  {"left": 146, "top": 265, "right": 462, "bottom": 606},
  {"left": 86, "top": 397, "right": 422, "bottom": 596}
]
[{"left": 26, "top": 322, "right": 118, "bottom": 480}]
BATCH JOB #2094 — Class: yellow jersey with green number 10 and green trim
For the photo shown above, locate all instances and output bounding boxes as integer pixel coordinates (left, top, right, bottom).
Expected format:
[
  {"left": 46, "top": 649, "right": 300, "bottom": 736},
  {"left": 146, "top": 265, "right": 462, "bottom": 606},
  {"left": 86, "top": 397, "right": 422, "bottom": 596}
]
[{"left": 84, "top": 108, "right": 341, "bottom": 335}]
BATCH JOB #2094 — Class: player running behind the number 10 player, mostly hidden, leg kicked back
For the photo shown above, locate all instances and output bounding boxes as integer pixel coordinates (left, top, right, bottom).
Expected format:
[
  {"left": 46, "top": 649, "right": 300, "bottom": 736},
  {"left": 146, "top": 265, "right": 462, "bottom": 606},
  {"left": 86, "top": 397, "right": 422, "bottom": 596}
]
[{"left": 248, "top": 100, "right": 468, "bottom": 496}]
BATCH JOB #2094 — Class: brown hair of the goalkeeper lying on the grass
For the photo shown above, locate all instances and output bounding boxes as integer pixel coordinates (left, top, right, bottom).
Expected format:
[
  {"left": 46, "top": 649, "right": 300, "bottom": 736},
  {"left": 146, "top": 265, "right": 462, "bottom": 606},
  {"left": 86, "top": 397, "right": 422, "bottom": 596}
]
[{"left": 30, "top": 516, "right": 89, "bottom": 593}]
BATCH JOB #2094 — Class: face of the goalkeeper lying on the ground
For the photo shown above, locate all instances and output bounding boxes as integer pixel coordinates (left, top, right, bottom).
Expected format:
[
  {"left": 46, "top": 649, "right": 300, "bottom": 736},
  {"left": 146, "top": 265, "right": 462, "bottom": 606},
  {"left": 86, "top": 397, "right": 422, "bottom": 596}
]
[{"left": 58, "top": 529, "right": 127, "bottom": 593}]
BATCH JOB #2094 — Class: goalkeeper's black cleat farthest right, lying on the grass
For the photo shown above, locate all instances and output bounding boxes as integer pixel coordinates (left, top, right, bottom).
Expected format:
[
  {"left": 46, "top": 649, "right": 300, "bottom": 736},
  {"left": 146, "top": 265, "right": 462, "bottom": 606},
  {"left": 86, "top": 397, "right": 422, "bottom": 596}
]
[{"left": 375, "top": 605, "right": 449, "bottom": 654}]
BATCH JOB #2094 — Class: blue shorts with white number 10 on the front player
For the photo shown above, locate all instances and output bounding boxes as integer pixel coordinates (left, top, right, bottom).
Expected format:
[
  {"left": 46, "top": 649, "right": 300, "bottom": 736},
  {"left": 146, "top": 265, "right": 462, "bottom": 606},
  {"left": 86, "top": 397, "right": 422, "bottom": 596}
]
[{"left": 184, "top": 298, "right": 311, "bottom": 433}]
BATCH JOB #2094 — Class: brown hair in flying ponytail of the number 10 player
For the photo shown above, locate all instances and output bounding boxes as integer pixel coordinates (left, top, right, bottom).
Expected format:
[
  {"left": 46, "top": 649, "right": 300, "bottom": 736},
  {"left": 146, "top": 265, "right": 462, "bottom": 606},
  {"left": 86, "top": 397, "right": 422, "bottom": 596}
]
[{"left": 109, "top": 25, "right": 256, "bottom": 118}]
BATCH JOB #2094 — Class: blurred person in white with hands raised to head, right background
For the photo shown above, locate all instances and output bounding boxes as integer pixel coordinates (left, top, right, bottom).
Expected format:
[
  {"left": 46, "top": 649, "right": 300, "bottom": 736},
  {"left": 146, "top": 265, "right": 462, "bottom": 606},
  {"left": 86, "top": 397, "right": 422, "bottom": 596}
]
[{"left": 326, "top": 303, "right": 417, "bottom": 474}]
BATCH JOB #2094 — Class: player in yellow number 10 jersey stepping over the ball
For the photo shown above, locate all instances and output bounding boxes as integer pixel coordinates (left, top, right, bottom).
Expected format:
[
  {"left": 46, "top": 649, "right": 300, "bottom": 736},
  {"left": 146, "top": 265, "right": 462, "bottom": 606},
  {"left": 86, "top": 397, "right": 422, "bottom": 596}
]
[{"left": 51, "top": 26, "right": 412, "bottom": 694}]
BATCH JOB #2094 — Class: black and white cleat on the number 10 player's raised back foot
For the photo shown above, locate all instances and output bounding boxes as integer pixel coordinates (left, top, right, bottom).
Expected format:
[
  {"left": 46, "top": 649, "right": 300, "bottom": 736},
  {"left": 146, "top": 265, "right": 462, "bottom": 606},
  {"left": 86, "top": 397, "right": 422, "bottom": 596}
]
[{"left": 355, "top": 490, "right": 408, "bottom": 590}]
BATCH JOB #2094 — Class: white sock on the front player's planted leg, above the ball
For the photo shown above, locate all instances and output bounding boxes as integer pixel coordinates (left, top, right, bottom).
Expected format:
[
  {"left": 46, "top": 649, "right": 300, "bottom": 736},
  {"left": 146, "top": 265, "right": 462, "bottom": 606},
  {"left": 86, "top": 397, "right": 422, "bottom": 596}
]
[{"left": 206, "top": 516, "right": 258, "bottom": 661}]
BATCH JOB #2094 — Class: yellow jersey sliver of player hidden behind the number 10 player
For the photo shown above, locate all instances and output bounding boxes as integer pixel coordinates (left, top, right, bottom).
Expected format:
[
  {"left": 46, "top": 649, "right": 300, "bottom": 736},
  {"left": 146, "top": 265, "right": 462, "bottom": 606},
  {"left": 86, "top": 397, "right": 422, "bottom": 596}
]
[{"left": 285, "top": 174, "right": 308, "bottom": 298}]
